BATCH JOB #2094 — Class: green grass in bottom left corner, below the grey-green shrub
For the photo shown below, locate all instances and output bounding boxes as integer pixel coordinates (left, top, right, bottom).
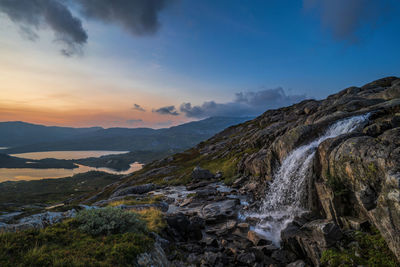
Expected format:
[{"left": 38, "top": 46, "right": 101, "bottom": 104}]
[{"left": 0, "top": 220, "right": 154, "bottom": 267}]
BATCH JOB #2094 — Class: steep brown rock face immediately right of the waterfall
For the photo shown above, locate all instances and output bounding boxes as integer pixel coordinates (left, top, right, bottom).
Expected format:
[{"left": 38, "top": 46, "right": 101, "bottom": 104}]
[{"left": 317, "top": 110, "right": 400, "bottom": 258}]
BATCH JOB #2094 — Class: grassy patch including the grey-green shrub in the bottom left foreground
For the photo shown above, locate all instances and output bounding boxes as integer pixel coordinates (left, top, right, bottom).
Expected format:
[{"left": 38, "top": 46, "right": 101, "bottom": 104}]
[{"left": 0, "top": 207, "right": 166, "bottom": 267}]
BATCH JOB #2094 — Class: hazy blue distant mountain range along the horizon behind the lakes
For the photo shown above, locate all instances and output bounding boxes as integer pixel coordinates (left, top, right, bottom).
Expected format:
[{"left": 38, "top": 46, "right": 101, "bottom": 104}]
[{"left": 0, "top": 117, "right": 252, "bottom": 154}]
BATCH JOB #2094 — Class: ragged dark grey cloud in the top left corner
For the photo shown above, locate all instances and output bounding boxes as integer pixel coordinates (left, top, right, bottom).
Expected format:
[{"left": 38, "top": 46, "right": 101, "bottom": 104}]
[{"left": 0, "top": 0, "right": 88, "bottom": 56}]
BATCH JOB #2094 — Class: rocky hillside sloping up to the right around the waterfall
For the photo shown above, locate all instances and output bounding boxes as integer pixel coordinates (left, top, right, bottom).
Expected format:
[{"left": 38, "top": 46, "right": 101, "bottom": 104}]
[{"left": 84, "top": 77, "right": 400, "bottom": 266}]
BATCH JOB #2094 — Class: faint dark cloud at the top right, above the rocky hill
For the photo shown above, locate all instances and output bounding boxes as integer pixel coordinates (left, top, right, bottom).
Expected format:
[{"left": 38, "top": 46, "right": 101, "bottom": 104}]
[{"left": 303, "top": 0, "right": 392, "bottom": 41}]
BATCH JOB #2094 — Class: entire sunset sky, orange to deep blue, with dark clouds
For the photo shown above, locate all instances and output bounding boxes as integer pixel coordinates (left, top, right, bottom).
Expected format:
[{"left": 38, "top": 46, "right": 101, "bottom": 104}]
[{"left": 0, "top": 0, "right": 400, "bottom": 128}]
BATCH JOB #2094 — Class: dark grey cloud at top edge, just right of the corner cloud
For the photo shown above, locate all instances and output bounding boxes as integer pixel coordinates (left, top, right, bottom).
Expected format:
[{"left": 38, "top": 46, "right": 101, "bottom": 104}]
[{"left": 76, "top": 0, "right": 171, "bottom": 35}]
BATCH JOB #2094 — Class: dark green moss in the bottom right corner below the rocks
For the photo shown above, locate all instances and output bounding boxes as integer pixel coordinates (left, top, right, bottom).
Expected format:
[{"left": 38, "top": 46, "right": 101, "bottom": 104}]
[{"left": 321, "top": 229, "right": 399, "bottom": 267}]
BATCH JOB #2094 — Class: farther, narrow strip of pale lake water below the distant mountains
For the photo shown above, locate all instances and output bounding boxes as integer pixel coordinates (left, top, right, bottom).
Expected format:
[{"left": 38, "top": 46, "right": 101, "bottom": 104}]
[{"left": 10, "top": 150, "right": 129, "bottom": 159}]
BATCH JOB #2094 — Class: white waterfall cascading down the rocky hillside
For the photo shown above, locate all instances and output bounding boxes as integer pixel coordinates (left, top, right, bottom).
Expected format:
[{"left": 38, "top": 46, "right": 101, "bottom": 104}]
[{"left": 250, "top": 114, "right": 369, "bottom": 246}]
